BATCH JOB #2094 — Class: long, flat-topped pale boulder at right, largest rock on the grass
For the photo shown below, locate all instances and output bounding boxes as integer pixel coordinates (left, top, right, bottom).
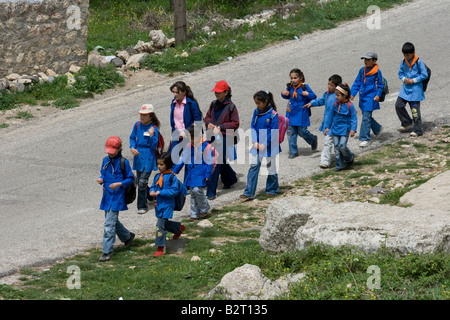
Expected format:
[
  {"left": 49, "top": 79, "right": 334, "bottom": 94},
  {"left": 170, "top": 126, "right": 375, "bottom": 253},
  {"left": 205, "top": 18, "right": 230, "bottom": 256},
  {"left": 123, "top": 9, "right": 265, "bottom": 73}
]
[{"left": 259, "top": 185, "right": 450, "bottom": 255}]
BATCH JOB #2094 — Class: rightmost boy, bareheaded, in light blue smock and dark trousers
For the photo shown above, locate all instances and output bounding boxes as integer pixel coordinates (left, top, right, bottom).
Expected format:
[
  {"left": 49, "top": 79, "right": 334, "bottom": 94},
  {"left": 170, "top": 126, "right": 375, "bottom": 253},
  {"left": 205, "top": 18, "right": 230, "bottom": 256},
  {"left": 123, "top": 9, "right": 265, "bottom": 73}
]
[{"left": 395, "top": 42, "right": 428, "bottom": 137}]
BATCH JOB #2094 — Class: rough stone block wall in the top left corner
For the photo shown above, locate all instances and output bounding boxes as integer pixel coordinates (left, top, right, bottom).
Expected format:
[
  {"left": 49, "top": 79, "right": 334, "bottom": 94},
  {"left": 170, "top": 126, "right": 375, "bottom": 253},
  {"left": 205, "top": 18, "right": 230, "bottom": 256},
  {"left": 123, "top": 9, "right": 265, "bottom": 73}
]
[{"left": 0, "top": 0, "right": 89, "bottom": 78}]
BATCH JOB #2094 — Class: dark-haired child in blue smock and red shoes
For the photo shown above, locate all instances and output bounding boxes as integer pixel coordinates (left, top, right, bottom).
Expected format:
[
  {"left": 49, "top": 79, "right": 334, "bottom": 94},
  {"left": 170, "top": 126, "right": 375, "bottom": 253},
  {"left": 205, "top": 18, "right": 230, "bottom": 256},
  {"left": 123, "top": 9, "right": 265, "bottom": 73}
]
[{"left": 150, "top": 152, "right": 186, "bottom": 257}]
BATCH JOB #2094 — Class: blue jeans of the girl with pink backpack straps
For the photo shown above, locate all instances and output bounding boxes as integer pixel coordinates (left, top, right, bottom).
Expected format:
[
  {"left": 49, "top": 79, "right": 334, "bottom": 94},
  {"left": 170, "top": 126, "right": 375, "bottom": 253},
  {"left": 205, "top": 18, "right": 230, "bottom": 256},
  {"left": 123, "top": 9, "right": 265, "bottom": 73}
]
[{"left": 244, "top": 156, "right": 279, "bottom": 199}]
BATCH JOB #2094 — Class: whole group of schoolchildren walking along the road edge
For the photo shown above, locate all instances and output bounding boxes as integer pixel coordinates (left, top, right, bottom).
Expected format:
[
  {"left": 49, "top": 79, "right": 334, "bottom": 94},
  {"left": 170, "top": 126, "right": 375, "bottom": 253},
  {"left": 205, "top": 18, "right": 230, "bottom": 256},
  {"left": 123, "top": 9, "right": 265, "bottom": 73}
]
[{"left": 97, "top": 43, "right": 428, "bottom": 261}]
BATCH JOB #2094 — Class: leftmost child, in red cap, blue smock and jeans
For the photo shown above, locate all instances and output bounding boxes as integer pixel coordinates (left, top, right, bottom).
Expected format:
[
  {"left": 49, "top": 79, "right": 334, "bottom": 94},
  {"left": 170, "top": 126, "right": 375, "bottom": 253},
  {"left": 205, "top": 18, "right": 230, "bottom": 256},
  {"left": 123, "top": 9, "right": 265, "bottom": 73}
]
[{"left": 97, "top": 136, "right": 135, "bottom": 262}]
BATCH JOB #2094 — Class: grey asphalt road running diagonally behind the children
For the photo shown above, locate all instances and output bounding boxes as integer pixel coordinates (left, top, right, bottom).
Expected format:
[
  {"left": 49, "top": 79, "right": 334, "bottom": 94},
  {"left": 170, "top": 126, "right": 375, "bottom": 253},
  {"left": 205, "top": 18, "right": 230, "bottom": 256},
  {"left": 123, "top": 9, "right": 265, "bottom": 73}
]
[{"left": 0, "top": 0, "right": 450, "bottom": 276}]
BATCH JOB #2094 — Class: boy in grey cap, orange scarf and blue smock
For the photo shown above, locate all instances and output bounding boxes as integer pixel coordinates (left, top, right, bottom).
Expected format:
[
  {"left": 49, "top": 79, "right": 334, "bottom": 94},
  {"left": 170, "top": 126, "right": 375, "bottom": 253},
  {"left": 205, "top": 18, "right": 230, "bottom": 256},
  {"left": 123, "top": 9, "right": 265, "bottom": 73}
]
[{"left": 350, "top": 52, "right": 384, "bottom": 148}]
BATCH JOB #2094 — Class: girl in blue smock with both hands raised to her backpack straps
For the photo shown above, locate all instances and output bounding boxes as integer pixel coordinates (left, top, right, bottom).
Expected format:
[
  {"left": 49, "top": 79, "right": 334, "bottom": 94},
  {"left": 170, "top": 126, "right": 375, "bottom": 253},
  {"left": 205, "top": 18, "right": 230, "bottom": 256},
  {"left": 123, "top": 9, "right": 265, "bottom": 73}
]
[{"left": 281, "top": 69, "right": 317, "bottom": 159}]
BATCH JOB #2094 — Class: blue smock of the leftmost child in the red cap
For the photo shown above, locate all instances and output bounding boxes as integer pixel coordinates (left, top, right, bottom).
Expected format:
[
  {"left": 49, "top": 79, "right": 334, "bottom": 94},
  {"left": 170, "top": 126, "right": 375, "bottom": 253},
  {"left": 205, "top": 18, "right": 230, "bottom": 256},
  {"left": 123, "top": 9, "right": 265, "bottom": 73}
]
[{"left": 100, "top": 154, "right": 134, "bottom": 211}]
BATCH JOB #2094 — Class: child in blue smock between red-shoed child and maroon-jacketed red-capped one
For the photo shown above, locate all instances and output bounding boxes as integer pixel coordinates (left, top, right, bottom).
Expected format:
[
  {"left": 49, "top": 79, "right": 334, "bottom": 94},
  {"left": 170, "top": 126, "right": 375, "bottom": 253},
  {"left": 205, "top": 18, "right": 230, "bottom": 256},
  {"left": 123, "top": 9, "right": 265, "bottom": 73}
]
[{"left": 173, "top": 125, "right": 214, "bottom": 221}]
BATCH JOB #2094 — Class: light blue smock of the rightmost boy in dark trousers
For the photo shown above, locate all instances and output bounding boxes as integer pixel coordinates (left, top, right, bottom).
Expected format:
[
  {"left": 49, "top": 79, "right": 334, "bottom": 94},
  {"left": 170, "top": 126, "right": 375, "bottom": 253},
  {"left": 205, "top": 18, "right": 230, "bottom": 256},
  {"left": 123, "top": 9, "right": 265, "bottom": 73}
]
[{"left": 398, "top": 59, "right": 428, "bottom": 101}]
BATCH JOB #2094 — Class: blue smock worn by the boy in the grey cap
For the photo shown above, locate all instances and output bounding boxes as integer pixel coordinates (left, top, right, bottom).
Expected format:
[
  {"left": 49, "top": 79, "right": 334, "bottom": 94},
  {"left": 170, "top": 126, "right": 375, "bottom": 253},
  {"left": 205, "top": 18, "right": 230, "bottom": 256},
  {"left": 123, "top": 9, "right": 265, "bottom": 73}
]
[{"left": 351, "top": 67, "right": 384, "bottom": 112}]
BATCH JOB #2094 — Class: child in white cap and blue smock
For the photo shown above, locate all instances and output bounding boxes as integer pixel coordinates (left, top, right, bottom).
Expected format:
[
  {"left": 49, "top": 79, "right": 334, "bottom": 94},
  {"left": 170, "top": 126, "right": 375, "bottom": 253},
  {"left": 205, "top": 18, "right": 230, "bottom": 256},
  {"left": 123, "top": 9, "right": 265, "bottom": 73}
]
[{"left": 130, "top": 104, "right": 160, "bottom": 214}]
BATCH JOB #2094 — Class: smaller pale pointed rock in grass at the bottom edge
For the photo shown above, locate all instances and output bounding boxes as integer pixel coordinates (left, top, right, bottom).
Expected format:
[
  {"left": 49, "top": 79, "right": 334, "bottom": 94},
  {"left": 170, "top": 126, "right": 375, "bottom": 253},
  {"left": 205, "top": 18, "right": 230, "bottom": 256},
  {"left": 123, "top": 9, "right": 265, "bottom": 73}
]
[{"left": 206, "top": 264, "right": 304, "bottom": 300}]
